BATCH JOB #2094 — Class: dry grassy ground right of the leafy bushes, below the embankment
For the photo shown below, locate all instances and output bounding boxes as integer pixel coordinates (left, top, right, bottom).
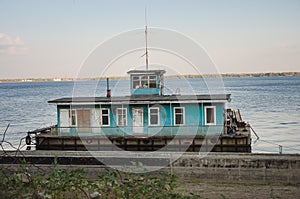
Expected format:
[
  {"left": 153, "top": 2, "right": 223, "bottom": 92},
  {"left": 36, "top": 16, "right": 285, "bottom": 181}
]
[{"left": 176, "top": 179, "right": 300, "bottom": 199}]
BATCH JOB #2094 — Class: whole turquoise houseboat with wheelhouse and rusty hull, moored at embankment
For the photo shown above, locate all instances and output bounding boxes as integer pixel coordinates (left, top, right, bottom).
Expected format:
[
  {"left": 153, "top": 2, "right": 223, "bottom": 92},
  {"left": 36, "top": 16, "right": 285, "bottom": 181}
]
[{"left": 26, "top": 68, "right": 251, "bottom": 152}]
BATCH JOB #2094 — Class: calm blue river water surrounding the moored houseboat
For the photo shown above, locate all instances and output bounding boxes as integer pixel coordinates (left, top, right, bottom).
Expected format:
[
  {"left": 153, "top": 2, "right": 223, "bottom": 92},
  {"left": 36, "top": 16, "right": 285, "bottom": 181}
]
[{"left": 0, "top": 77, "right": 300, "bottom": 153}]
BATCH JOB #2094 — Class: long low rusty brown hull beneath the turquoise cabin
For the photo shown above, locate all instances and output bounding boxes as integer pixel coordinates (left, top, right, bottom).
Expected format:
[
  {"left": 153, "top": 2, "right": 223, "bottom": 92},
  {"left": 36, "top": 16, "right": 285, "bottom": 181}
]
[{"left": 35, "top": 134, "right": 251, "bottom": 153}]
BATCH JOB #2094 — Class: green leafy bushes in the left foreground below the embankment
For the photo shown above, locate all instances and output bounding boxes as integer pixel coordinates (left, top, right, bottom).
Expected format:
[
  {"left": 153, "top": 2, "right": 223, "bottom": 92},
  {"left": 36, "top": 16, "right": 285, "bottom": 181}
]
[{"left": 0, "top": 161, "right": 200, "bottom": 199}]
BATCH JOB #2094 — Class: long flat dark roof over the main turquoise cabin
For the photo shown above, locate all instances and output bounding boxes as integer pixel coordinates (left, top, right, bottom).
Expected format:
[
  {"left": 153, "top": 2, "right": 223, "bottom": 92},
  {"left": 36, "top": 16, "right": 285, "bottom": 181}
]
[{"left": 48, "top": 94, "right": 230, "bottom": 104}]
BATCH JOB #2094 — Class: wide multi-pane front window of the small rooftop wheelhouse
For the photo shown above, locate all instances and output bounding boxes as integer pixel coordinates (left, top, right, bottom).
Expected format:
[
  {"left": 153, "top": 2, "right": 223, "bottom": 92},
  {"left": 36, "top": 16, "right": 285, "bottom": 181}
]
[{"left": 132, "top": 75, "right": 157, "bottom": 89}]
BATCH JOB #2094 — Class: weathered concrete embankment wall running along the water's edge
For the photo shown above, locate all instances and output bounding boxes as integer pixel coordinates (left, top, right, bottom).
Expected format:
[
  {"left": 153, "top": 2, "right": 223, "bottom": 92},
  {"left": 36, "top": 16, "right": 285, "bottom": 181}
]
[{"left": 0, "top": 151, "right": 300, "bottom": 184}]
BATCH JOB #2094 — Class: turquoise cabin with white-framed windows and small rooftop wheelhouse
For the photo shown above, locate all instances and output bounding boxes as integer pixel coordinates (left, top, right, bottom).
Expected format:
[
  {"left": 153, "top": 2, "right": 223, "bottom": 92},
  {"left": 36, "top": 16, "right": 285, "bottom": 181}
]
[{"left": 49, "top": 70, "right": 230, "bottom": 137}]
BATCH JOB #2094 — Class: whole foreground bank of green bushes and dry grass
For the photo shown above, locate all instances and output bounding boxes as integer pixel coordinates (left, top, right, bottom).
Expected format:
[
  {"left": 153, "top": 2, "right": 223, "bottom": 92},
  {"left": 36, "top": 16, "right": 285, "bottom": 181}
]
[{"left": 0, "top": 161, "right": 300, "bottom": 199}]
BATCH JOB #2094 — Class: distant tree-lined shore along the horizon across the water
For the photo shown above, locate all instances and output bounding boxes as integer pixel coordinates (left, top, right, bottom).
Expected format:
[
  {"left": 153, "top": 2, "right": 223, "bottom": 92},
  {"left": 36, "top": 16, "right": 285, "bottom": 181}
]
[{"left": 0, "top": 72, "right": 300, "bottom": 83}]
